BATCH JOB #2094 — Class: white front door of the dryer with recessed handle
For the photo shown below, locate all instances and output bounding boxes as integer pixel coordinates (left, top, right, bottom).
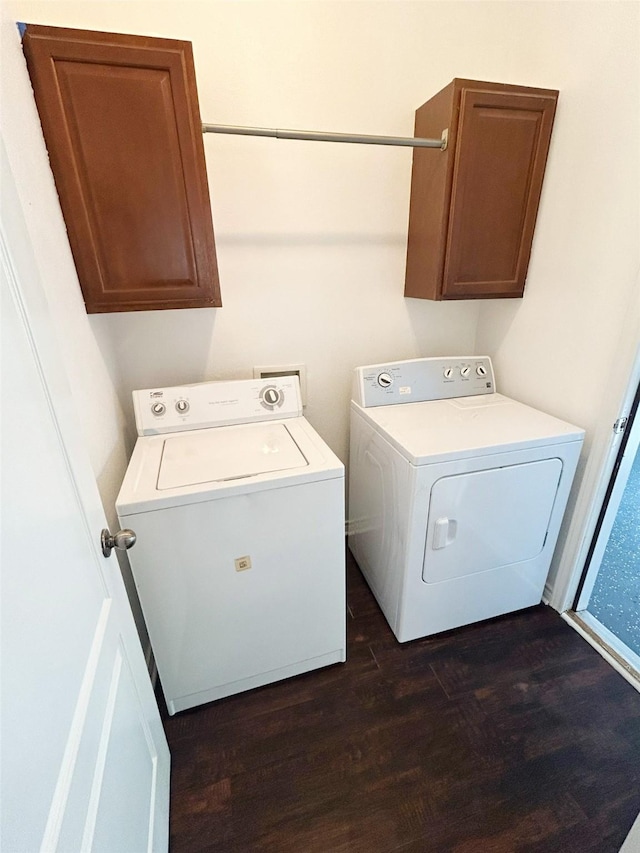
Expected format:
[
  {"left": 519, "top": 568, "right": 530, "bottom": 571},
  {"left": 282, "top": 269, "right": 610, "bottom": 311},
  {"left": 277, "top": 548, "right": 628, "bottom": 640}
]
[{"left": 422, "top": 459, "right": 562, "bottom": 583}]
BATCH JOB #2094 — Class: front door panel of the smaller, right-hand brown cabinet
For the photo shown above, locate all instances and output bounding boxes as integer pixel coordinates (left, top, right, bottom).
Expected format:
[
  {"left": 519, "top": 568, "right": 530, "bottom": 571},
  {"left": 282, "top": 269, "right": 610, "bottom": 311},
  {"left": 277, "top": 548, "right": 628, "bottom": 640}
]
[{"left": 442, "top": 89, "right": 556, "bottom": 299}]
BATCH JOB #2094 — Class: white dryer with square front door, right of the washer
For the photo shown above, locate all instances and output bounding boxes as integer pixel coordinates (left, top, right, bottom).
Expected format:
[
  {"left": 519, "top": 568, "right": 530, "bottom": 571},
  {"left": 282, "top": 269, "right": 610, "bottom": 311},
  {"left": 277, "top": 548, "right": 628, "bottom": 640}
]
[{"left": 349, "top": 357, "right": 584, "bottom": 642}]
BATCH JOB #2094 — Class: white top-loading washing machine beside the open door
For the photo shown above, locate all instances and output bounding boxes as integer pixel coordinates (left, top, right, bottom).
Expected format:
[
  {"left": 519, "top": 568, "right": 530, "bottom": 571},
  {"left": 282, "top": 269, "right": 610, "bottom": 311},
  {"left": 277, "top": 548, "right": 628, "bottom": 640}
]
[{"left": 116, "top": 377, "right": 346, "bottom": 714}]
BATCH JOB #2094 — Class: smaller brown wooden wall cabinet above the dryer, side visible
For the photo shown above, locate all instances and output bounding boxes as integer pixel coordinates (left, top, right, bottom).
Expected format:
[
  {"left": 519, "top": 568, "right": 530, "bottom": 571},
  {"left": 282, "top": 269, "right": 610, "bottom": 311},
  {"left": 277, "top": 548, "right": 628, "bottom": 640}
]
[{"left": 405, "top": 79, "right": 558, "bottom": 299}]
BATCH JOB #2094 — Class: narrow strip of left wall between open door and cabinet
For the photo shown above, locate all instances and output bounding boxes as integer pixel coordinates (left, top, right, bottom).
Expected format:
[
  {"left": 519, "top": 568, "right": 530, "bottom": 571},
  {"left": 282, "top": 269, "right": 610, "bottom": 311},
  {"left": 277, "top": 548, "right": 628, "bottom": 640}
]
[{"left": 0, "top": 4, "right": 147, "bottom": 647}]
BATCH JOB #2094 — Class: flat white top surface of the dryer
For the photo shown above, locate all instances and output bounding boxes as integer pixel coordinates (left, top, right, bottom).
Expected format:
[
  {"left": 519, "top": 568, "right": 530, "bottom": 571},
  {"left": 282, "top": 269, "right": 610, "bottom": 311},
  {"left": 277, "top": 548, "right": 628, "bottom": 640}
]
[{"left": 351, "top": 394, "right": 584, "bottom": 465}]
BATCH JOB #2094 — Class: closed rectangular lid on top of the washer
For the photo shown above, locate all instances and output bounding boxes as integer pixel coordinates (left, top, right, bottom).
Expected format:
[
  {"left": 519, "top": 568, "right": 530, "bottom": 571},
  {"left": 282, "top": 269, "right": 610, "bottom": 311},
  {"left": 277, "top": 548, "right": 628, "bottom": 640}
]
[{"left": 158, "top": 423, "right": 309, "bottom": 490}]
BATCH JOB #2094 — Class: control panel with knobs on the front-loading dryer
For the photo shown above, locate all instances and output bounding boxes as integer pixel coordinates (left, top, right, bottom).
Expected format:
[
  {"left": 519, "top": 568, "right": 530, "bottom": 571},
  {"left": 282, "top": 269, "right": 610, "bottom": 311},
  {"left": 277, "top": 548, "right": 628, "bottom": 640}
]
[{"left": 353, "top": 355, "right": 496, "bottom": 408}]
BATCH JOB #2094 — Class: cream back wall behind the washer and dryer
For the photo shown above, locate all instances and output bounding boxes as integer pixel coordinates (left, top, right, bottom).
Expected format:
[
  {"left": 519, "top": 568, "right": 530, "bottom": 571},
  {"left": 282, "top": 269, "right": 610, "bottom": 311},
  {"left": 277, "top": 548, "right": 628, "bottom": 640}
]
[{"left": 2, "top": 2, "right": 492, "bottom": 466}]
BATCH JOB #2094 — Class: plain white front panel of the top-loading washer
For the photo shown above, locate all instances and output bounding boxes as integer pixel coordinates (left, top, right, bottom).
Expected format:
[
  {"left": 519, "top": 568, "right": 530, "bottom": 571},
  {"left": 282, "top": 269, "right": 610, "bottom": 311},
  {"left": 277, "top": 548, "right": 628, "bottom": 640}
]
[{"left": 121, "top": 478, "right": 346, "bottom": 713}]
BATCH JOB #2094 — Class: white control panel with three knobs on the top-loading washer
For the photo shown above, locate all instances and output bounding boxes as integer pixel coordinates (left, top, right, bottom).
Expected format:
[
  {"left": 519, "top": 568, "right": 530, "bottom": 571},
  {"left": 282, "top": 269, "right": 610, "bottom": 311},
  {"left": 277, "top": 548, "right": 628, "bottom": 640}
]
[{"left": 133, "top": 376, "right": 302, "bottom": 435}]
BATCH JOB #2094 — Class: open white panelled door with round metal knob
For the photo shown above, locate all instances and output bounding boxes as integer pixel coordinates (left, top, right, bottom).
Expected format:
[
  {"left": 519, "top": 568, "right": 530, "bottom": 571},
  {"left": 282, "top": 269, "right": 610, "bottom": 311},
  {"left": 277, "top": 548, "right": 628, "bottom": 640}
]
[{"left": 0, "top": 143, "right": 169, "bottom": 853}]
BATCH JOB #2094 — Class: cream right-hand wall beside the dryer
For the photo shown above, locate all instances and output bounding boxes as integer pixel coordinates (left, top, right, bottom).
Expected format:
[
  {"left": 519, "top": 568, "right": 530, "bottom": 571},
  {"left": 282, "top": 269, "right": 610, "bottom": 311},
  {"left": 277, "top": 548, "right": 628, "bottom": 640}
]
[{"left": 477, "top": 3, "right": 640, "bottom": 605}]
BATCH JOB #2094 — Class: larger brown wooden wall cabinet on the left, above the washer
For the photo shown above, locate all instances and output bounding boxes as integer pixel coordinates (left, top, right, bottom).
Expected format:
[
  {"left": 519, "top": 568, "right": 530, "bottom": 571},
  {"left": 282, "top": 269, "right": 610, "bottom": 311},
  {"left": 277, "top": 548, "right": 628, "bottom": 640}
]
[{"left": 23, "top": 25, "right": 221, "bottom": 313}]
